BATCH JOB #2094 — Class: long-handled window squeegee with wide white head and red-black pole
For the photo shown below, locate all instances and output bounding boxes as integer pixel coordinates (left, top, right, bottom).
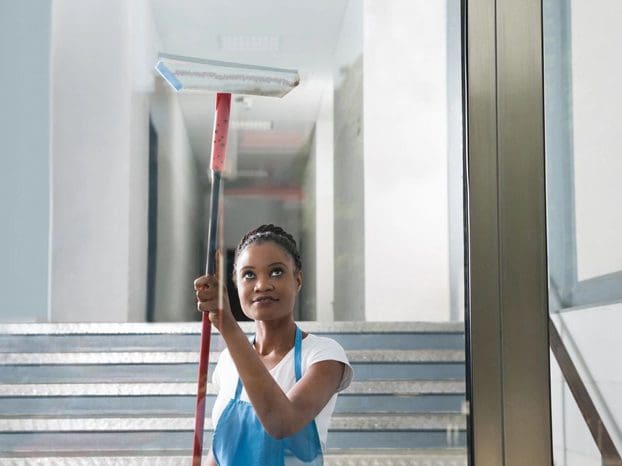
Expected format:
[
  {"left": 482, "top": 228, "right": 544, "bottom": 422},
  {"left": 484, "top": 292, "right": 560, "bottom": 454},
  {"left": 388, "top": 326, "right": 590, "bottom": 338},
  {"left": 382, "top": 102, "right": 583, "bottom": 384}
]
[{"left": 155, "top": 53, "right": 300, "bottom": 466}]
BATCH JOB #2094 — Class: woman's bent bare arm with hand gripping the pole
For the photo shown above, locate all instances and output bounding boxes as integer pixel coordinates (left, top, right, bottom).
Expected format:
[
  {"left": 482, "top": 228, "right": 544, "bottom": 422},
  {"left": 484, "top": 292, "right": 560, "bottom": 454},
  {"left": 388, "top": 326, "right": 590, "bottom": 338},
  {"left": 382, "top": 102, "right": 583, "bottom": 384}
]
[{"left": 195, "top": 276, "right": 345, "bottom": 438}]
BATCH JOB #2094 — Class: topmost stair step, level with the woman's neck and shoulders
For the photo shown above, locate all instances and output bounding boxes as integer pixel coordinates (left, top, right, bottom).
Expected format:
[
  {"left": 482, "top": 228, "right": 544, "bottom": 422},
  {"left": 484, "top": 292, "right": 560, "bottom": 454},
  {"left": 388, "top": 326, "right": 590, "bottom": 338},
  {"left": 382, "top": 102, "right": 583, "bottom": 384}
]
[{"left": 0, "top": 322, "right": 464, "bottom": 352}]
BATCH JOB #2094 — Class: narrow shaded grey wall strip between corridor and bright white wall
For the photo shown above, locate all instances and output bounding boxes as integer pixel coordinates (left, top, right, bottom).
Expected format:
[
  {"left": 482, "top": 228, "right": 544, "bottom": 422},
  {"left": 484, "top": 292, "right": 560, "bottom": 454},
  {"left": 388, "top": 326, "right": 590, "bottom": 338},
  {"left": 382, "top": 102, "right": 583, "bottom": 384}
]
[{"left": 333, "top": 0, "right": 367, "bottom": 320}]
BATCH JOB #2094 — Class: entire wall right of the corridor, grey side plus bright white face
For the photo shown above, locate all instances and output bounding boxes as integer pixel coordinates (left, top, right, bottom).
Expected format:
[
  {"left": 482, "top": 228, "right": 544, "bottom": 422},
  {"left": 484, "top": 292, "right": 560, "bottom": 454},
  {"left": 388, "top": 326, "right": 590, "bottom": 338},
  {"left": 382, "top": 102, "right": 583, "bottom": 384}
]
[{"left": 333, "top": 0, "right": 464, "bottom": 321}]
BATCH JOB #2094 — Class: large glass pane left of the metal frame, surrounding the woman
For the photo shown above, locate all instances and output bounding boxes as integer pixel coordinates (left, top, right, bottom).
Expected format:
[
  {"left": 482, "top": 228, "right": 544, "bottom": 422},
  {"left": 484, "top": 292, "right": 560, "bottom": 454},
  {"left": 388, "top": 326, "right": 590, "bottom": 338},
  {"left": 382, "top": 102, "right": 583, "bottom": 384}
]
[{"left": 0, "top": 0, "right": 467, "bottom": 465}]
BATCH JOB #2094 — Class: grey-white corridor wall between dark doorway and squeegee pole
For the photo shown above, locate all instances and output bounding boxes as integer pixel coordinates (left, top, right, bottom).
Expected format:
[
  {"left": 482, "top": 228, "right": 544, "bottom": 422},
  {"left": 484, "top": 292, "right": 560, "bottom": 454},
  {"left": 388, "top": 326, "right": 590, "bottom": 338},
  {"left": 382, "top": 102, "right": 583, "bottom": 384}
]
[{"left": 152, "top": 78, "right": 202, "bottom": 322}]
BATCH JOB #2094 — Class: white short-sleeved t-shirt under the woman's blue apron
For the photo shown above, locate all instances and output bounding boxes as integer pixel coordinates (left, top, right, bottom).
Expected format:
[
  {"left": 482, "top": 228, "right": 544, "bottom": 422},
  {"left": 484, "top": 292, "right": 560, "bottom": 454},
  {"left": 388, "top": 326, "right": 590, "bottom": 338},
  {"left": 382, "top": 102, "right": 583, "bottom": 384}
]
[{"left": 212, "top": 334, "right": 352, "bottom": 448}]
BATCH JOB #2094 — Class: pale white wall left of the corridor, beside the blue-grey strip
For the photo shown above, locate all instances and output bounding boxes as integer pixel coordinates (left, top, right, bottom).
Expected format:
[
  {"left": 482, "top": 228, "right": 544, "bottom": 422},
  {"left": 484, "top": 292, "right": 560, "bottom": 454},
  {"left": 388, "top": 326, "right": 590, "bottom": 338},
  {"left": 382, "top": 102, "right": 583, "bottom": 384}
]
[{"left": 50, "top": 0, "right": 157, "bottom": 322}]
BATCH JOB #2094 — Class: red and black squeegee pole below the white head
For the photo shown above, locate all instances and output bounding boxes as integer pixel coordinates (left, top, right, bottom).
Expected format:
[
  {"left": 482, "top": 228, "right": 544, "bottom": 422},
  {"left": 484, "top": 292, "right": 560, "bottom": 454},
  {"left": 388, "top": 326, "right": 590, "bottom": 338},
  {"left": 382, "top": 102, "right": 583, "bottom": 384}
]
[{"left": 192, "top": 93, "right": 231, "bottom": 466}]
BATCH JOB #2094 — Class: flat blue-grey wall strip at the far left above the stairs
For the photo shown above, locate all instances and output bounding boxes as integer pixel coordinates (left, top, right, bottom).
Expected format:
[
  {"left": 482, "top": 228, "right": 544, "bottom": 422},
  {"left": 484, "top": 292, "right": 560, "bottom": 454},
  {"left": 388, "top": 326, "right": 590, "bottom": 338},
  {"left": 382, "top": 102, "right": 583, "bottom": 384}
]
[{"left": 0, "top": 2, "right": 51, "bottom": 322}]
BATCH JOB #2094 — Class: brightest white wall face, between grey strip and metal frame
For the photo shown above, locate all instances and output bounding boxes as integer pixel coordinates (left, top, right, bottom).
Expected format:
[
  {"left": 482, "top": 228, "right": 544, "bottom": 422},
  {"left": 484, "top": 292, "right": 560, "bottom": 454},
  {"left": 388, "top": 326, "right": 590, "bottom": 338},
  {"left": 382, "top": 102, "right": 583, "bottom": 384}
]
[{"left": 363, "top": 0, "right": 449, "bottom": 321}]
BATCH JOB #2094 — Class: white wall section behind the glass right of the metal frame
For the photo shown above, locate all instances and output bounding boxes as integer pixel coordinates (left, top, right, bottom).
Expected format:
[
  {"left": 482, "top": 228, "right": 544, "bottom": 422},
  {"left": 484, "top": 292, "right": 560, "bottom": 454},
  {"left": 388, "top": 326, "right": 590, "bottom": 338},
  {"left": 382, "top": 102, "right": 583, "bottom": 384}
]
[{"left": 569, "top": 0, "right": 622, "bottom": 280}]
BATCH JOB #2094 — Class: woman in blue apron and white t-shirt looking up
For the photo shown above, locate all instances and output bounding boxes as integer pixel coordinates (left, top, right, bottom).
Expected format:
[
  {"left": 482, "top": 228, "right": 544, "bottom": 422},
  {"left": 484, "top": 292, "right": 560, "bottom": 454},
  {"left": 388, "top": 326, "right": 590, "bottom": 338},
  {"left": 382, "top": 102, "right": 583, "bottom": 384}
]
[{"left": 194, "top": 225, "right": 352, "bottom": 466}]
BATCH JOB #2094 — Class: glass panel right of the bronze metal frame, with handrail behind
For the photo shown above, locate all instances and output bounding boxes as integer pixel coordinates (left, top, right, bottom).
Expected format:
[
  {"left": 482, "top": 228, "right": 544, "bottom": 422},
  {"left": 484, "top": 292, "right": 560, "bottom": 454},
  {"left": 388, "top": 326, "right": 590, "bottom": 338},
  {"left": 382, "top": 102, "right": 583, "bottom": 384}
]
[{"left": 543, "top": 0, "right": 622, "bottom": 465}]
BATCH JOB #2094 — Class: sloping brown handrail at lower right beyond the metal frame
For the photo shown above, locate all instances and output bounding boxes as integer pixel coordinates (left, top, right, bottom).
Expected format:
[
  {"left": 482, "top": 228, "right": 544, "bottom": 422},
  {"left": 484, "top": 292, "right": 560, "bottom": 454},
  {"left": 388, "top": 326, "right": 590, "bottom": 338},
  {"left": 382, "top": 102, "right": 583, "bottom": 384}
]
[{"left": 549, "top": 317, "right": 622, "bottom": 466}]
